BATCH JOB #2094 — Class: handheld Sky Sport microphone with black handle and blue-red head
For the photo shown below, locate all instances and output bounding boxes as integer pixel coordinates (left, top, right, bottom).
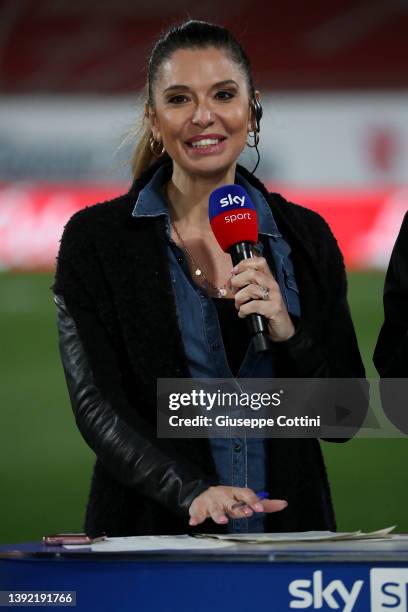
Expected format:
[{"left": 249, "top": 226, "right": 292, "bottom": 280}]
[{"left": 208, "top": 185, "right": 270, "bottom": 352}]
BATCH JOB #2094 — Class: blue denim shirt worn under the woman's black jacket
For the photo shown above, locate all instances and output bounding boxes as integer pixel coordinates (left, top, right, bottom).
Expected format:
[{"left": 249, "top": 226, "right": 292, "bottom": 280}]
[{"left": 132, "top": 168, "right": 300, "bottom": 533}]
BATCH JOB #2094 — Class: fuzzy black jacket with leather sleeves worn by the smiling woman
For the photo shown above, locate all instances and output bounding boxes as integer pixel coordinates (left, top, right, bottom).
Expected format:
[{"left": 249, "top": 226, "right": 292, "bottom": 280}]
[{"left": 52, "top": 164, "right": 364, "bottom": 536}]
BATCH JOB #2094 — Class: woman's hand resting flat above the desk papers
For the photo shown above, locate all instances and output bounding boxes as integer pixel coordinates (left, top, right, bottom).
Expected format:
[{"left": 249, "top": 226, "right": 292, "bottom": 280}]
[{"left": 189, "top": 486, "right": 288, "bottom": 526}]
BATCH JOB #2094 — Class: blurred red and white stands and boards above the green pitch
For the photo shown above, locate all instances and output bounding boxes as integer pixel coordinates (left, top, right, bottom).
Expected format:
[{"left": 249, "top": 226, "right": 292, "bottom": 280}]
[{"left": 0, "top": 0, "right": 408, "bottom": 269}]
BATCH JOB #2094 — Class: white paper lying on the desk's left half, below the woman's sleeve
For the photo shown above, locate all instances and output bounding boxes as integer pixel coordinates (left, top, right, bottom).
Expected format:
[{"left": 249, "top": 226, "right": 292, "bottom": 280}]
[{"left": 64, "top": 535, "right": 234, "bottom": 552}]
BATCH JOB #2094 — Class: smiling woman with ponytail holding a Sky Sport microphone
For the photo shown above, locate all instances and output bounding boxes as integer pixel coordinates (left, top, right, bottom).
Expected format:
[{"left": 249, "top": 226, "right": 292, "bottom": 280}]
[{"left": 53, "top": 21, "right": 364, "bottom": 536}]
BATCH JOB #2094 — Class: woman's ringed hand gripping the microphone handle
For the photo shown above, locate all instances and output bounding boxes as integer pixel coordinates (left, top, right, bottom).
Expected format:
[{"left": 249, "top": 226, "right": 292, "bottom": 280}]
[{"left": 230, "top": 257, "right": 295, "bottom": 342}]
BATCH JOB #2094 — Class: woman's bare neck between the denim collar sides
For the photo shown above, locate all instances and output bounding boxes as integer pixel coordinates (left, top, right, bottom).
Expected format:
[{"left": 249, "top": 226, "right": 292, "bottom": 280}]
[{"left": 166, "top": 164, "right": 235, "bottom": 230}]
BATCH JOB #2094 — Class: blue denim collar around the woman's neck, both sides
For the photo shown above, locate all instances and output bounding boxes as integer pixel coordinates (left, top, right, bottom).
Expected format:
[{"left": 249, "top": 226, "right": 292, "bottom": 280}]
[{"left": 132, "top": 166, "right": 281, "bottom": 238}]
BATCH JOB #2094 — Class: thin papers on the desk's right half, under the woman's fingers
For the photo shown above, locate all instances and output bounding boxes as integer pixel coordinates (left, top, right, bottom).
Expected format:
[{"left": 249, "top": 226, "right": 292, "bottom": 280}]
[{"left": 195, "top": 525, "right": 395, "bottom": 544}]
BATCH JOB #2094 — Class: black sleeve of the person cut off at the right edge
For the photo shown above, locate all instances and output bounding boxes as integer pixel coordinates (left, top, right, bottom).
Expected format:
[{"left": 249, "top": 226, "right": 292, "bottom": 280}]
[{"left": 374, "top": 213, "right": 408, "bottom": 378}]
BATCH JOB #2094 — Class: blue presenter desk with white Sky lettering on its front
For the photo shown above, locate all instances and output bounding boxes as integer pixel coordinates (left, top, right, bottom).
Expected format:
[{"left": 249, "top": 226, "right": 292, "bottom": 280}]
[{"left": 0, "top": 536, "right": 408, "bottom": 612}]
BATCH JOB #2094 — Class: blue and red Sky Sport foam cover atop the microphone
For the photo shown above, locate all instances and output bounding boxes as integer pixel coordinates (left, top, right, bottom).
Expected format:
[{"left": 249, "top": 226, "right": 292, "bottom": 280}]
[{"left": 208, "top": 185, "right": 258, "bottom": 253}]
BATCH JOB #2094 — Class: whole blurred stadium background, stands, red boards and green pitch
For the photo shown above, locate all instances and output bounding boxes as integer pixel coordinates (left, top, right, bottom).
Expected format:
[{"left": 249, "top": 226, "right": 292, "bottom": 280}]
[{"left": 0, "top": 0, "right": 408, "bottom": 542}]
